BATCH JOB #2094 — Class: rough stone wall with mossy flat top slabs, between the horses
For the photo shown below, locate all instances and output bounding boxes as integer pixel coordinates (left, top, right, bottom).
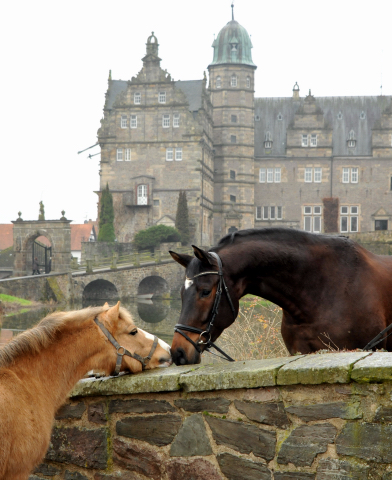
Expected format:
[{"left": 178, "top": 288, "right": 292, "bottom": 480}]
[{"left": 30, "top": 352, "right": 392, "bottom": 480}]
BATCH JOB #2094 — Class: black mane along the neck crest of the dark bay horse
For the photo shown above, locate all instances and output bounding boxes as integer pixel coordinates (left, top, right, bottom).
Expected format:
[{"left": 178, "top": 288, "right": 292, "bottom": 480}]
[{"left": 214, "top": 227, "right": 348, "bottom": 249}]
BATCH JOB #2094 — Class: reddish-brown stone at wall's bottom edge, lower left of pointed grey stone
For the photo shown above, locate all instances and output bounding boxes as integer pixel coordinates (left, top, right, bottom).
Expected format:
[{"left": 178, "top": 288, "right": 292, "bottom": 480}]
[{"left": 113, "top": 438, "right": 161, "bottom": 478}]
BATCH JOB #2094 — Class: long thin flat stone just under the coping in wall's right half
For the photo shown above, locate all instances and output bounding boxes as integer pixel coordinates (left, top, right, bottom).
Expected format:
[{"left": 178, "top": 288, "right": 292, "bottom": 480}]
[{"left": 286, "top": 402, "right": 362, "bottom": 422}]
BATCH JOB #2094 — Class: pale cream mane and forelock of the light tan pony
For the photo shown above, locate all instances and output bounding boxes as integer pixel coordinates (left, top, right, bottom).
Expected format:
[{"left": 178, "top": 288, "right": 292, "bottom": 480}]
[{"left": 0, "top": 307, "right": 133, "bottom": 367}]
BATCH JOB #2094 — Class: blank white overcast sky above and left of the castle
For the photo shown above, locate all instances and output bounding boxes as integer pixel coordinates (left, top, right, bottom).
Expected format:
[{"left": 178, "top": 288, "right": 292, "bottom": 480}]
[{"left": 0, "top": 0, "right": 392, "bottom": 223}]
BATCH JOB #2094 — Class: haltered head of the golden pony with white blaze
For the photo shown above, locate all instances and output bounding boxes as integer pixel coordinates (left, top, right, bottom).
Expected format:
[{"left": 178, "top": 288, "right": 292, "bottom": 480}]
[{"left": 95, "top": 302, "right": 172, "bottom": 374}]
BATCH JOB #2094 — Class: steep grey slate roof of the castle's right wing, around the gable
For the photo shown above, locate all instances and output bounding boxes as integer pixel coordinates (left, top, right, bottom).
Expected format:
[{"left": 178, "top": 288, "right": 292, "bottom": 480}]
[{"left": 255, "top": 95, "right": 392, "bottom": 157}]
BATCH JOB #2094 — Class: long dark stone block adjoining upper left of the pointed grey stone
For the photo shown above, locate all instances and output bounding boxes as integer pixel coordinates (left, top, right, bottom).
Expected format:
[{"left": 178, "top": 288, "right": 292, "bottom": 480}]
[{"left": 116, "top": 415, "right": 182, "bottom": 446}]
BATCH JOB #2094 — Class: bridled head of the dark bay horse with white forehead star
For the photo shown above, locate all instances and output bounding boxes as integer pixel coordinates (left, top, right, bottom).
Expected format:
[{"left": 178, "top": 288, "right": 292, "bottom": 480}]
[{"left": 169, "top": 245, "right": 238, "bottom": 365}]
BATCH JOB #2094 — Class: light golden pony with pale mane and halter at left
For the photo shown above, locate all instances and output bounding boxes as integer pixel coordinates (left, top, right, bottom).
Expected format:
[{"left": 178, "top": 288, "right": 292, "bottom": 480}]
[{"left": 0, "top": 302, "right": 172, "bottom": 480}]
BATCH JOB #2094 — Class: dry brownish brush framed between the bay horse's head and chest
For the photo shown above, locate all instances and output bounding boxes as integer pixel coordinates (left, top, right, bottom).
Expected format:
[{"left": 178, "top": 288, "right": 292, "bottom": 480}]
[{"left": 217, "top": 297, "right": 289, "bottom": 360}]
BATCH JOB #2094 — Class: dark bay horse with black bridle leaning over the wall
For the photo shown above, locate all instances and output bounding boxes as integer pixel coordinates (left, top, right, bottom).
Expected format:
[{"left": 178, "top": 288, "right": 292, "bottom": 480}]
[{"left": 170, "top": 228, "right": 392, "bottom": 365}]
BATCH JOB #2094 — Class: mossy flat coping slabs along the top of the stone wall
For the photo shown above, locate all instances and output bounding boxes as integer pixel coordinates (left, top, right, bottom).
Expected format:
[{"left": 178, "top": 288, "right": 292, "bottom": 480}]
[{"left": 71, "top": 351, "right": 392, "bottom": 397}]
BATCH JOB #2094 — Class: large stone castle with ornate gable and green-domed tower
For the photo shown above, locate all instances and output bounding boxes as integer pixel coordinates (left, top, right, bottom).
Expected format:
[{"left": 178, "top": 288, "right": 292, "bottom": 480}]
[{"left": 98, "top": 18, "right": 392, "bottom": 245}]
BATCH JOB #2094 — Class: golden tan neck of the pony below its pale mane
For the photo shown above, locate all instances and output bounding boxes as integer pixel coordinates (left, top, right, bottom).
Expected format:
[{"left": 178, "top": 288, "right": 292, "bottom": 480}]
[{"left": 11, "top": 328, "right": 108, "bottom": 410}]
